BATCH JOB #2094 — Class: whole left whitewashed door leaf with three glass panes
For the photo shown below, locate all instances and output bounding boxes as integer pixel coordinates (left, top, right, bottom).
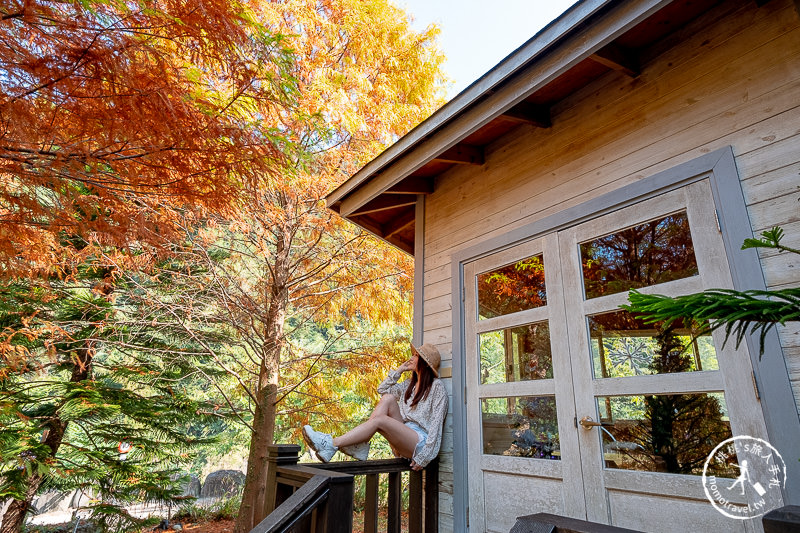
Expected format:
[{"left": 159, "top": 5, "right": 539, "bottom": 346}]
[{"left": 464, "top": 237, "right": 586, "bottom": 533}]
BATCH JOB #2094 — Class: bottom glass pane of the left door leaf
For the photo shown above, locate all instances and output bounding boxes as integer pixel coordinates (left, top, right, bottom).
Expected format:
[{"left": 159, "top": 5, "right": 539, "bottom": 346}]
[{"left": 481, "top": 396, "right": 561, "bottom": 459}]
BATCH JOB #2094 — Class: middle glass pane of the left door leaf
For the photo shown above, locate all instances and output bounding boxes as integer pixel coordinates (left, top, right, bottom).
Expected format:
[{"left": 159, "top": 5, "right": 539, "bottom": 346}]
[{"left": 479, "top": 322, "right": 553, "bottom": 383}]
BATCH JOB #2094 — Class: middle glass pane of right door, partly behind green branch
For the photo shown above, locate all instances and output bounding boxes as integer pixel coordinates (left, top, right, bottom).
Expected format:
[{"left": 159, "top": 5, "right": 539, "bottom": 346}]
[{"left": 589, "top": 311, "right": 719, "bottom": 378}]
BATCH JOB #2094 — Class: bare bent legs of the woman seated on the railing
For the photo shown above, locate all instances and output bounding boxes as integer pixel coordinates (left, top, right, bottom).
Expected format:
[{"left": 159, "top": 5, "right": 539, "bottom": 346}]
[{"left": 333, "top": 394, "right": 419, "bottom": 458}]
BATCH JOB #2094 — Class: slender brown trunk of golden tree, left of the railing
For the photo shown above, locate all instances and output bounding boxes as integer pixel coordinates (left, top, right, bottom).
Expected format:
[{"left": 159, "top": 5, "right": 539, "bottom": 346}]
[{"left": 233, "top": 223, "right": 291, "bottom": 533}]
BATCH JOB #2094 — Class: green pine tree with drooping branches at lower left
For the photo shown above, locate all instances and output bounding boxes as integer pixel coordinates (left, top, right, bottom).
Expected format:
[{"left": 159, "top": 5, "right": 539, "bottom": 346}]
[{"left": 0, "top": 250, "right": 225, "bottom": 533}]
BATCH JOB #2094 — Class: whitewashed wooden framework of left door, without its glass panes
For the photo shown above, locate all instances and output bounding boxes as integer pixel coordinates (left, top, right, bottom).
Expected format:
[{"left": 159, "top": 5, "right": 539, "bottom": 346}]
[{"left": 464, "top": 237, "right": 586, "bottom": 525}]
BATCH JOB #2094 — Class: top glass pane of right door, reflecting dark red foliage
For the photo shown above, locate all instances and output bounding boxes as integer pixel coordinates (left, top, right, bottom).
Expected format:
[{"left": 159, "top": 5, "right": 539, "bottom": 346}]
[{"left": 581, "top": 212, "right": 697, "bottom": 299}]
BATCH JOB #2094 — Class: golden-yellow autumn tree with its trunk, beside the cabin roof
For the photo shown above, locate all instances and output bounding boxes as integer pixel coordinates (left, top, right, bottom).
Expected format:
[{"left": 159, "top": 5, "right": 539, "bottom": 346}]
[{"left": 183, "top": 0, "right": 450, "bottom": 532}]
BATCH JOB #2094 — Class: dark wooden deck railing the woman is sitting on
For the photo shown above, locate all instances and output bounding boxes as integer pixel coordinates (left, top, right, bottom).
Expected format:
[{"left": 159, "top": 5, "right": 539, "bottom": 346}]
[{"left": 251, "top": 444, "right": 439, "bottom": 533}]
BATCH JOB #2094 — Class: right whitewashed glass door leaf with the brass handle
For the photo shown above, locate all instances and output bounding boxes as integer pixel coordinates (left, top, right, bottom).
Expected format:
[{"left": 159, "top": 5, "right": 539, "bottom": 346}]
[{"left": 558, "top": 180, "right": 766, "bottom": 532}]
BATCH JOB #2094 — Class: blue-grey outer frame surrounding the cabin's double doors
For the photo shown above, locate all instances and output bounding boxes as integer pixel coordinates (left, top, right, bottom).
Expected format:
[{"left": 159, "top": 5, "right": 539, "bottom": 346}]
[{"left": 451, "top": 146, "right": 800, "bottom": 531}]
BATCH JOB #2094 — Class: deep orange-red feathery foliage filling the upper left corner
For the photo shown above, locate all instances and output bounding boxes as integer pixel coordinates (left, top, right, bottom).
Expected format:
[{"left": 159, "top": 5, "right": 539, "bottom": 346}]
[{"left": 0, "top": 0, "right": 294, "bottom": 275}]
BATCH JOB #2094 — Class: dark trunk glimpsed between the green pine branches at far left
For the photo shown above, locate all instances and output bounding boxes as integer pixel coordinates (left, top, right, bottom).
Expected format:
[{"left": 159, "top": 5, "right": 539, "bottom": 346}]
[{"left": 0, "top": 345, "right": 94, "bottom": 533}]
